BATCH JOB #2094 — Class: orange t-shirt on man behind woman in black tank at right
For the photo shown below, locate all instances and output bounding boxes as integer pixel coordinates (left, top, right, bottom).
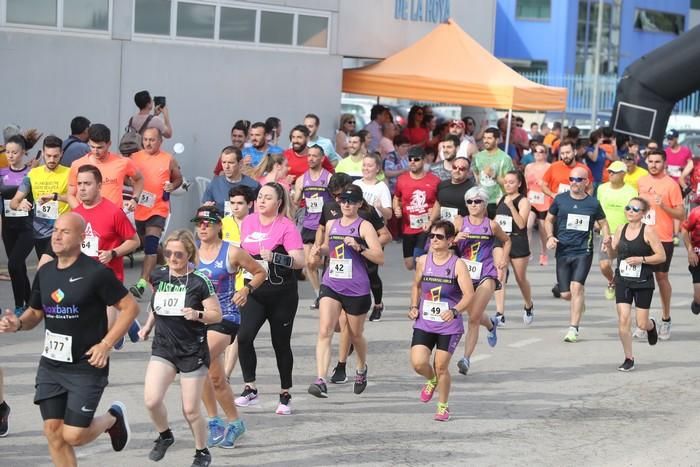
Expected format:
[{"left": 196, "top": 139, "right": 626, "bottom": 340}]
[{"left": 637, "top": 175, "right": 683, "bottom": 242}]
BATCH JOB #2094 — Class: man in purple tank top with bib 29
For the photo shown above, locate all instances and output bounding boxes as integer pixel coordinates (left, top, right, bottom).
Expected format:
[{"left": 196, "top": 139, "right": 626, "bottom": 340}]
[{"left": 293, "top": 145, "right": 331, "bottom": 309}]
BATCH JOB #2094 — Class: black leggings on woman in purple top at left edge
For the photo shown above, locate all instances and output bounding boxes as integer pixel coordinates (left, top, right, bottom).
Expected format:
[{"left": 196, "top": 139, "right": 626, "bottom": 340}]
[{"left": 2, "top": 226, "right": 34, "bottom": 307}]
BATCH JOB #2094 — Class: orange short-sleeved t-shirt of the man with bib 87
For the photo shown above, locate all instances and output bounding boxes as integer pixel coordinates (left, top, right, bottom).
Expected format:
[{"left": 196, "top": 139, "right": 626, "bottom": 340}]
[{"left": 68, "top": 152, "right": 138, "bottom": 206}]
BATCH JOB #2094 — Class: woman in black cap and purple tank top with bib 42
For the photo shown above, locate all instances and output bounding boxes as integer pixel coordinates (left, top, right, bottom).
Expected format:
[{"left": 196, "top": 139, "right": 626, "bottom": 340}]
[{"left": 309, "top": 185, "right": 384, "bottom": 397}]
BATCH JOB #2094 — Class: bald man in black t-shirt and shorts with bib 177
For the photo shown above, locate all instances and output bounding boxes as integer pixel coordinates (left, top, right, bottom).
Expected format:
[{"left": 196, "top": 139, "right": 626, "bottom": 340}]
[{"left": 0, "top": 213, "right": 138, "bottom": 466}]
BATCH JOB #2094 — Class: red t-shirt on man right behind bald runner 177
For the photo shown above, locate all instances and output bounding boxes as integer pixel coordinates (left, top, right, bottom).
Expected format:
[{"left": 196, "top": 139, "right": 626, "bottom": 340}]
[{"left": 73, "top": 198, "right": 136, "bottom": 282}]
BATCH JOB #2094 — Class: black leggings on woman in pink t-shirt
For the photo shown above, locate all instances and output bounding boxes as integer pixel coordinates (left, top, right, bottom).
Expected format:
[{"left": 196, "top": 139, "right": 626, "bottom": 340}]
[{"left": 238, "top": 284, "right": 299, "bottom": 389}]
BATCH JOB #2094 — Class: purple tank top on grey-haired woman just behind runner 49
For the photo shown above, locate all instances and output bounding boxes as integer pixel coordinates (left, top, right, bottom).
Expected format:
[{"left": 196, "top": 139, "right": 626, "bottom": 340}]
[{"left": 457, "top": 216, "right": 498, "bottom": 282}]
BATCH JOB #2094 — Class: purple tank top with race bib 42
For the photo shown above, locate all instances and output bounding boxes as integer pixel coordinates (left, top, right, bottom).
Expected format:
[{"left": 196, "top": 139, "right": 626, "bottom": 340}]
[{"left": 322, "top": 217, "right": 369, "bottom": 297}]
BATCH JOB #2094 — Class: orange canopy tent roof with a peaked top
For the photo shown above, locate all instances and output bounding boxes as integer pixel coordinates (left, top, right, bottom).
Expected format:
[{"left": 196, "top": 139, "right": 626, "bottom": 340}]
[{"left": 343, "top": 19, "right": 566, "bottom": 111}]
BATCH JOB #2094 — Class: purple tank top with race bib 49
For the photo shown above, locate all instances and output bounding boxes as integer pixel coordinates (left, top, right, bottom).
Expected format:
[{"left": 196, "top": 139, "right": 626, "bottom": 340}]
[{"left": 413, "top": 253, "right": 464, "bottom": 335}]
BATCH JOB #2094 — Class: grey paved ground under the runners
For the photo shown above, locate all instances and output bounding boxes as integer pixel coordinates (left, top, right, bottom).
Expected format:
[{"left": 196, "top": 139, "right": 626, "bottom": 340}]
[{"left": 0, "top": 239, "right": 700, "bottom": 467}]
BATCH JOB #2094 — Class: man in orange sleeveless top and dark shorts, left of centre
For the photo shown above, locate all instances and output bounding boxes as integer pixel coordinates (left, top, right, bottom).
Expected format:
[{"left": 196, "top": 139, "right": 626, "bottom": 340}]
[{"left": 129, "top": 128, "right": 182, "bottom": 298}]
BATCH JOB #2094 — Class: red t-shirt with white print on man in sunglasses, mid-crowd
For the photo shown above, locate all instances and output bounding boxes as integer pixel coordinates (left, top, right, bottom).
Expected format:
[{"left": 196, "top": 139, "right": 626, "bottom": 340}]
[{"left": 394, "top": 172, "right": 440, "bottom": 235}]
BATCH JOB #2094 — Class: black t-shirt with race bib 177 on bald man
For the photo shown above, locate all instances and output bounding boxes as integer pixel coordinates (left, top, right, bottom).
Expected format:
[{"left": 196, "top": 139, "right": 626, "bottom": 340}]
[{"left": 29, "top": 253, "right": 129, "bottom": 374}]
